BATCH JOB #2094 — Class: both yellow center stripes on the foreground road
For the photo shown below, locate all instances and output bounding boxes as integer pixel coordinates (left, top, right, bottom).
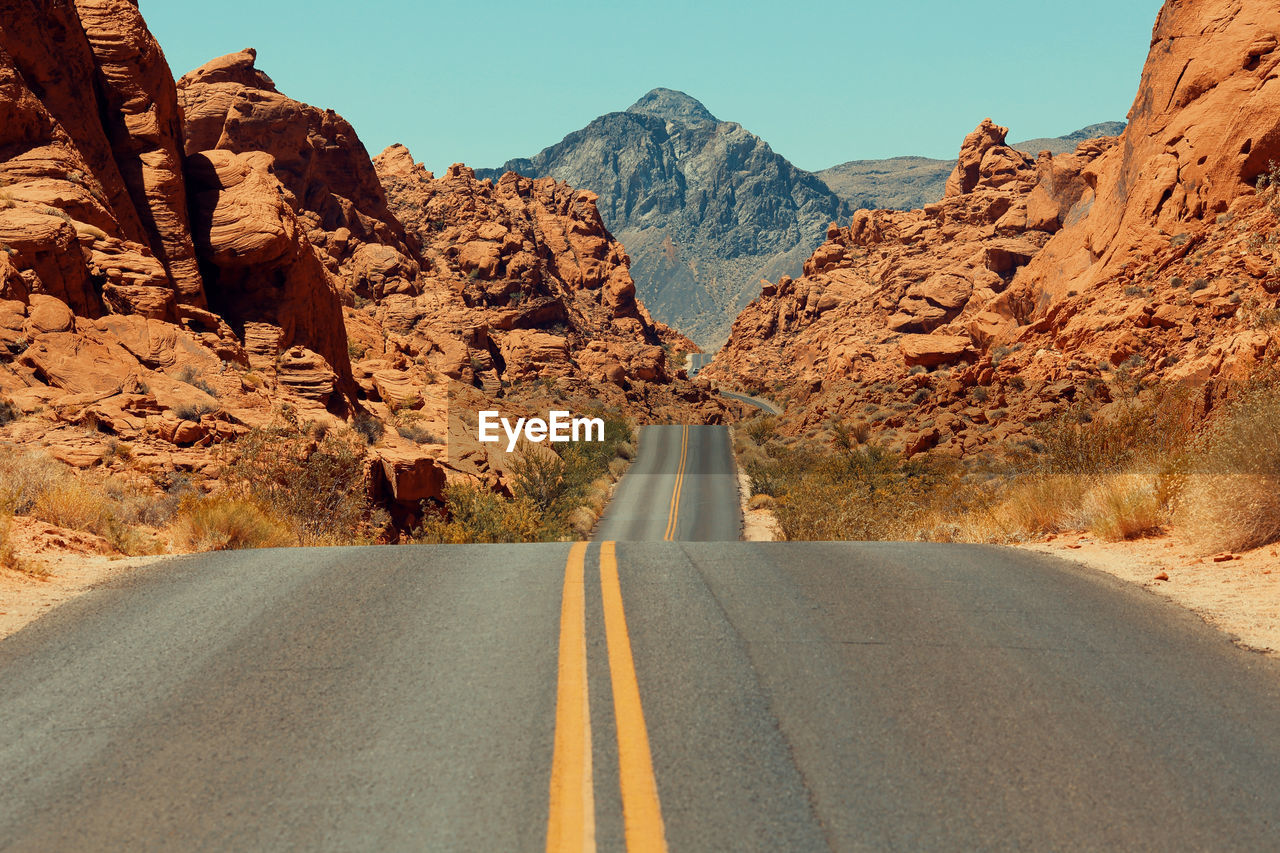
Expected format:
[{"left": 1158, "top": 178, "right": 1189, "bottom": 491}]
[{"left": 547, "top": 542, "right": 667, "bottom": 853}]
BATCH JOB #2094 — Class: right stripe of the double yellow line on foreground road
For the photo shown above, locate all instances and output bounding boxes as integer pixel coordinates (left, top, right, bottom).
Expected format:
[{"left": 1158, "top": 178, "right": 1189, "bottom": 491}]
[{"left": 600, "top": 542, "right": 667, "bottom": 853}]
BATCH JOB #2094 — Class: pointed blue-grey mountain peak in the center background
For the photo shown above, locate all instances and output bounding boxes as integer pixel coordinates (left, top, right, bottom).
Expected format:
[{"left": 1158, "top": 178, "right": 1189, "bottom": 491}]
[{"left": 476, "top": 88, "right": 847, "bottom": 347}]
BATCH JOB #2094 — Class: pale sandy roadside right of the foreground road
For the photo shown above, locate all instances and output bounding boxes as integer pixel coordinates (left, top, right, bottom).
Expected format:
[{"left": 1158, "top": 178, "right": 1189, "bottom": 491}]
[{"left": 1020, "top": 534, "right": 1280, "bottom": 656}]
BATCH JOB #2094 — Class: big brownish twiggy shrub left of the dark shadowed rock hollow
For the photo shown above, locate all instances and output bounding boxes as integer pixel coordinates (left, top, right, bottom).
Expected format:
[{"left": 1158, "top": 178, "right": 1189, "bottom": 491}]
[{"left": 223, "top": 414, "right": 372, "bottom": 546}]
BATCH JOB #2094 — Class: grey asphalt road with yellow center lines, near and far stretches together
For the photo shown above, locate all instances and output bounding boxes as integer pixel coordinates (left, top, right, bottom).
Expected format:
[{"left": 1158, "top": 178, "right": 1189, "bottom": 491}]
[{"left": 0, "top": 429, "right": 1280, "bottom": 850}]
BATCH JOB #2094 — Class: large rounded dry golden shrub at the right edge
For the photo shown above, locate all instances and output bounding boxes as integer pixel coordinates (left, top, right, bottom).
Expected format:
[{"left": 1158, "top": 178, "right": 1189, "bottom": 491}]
[{"left": 1178, "top": 380, "right": 1280, "bottom": 552}]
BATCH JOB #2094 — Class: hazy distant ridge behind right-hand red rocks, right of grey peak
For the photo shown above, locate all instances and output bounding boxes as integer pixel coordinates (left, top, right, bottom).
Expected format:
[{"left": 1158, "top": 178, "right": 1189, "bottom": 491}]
[{"left": 815, "top": 122, "right": 1125, "bottom": 210}]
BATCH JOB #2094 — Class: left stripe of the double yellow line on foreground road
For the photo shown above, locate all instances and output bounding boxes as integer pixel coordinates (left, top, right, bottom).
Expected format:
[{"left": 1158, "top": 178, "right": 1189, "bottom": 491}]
[{"left": 547, "top": 542, "right": 595, "bottom": 853}]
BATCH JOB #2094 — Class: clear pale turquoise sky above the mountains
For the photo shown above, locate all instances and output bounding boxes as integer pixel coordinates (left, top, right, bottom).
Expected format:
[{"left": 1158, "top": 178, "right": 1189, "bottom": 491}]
[{"left": 141, "top": 0, "right": 1161, "bottom": 172}]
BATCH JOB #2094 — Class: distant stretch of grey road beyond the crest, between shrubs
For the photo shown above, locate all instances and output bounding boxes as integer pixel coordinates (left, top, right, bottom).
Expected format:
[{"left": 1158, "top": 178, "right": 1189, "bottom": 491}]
[{"left": 593, "top": 427, "right": 742, "bottom": 542}]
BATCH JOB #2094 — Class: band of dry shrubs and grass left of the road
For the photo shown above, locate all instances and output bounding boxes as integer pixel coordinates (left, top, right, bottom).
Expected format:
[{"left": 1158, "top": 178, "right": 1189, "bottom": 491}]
[{"left": 0, "top": 399, "right": 635, "bottom": 575}]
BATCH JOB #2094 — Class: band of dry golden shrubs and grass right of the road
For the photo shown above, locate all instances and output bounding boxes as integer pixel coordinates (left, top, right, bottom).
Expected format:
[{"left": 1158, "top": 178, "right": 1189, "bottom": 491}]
[{"left": 735, "top": 375, "right": 1280, "bottom": 553}]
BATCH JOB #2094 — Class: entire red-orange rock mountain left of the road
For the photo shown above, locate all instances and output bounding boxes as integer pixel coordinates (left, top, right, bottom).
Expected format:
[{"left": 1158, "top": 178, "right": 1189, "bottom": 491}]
[{"left": 0, "top": 6, "right": 724, "bottom": 530}]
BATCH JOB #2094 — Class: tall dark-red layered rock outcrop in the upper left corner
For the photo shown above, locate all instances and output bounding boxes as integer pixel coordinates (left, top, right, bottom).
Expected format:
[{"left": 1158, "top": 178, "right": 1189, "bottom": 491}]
[{"left": 0, "top": 0, "right": 205, "bottom": 319}]
